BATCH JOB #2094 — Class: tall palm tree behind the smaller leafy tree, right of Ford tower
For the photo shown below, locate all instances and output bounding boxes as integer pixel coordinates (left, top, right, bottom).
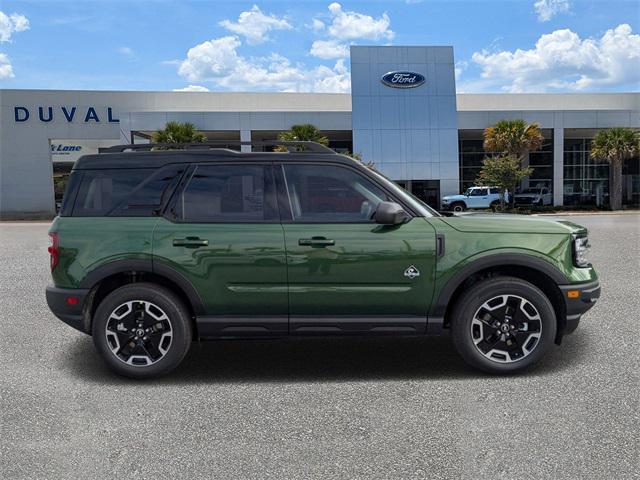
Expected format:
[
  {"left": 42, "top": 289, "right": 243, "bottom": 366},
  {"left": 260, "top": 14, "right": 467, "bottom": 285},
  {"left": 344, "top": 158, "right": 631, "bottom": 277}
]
[{"left": 483, "top": 119, "right": 544, "bottom": 207}]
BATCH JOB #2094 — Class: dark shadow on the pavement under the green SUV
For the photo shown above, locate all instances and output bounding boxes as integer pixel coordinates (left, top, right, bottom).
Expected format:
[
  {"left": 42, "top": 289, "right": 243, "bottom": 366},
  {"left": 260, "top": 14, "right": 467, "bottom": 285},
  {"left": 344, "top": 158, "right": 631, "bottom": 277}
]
[{"left": 61, "top": 336, "right": 585, "bottom": 384}]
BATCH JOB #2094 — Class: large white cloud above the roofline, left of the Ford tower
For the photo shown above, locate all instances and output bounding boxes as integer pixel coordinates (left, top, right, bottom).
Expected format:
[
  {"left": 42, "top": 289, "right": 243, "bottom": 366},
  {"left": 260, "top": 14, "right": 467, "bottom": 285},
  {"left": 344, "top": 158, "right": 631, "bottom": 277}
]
[{"left": 178, "top": 36, "right": 350, "bottom": 92}]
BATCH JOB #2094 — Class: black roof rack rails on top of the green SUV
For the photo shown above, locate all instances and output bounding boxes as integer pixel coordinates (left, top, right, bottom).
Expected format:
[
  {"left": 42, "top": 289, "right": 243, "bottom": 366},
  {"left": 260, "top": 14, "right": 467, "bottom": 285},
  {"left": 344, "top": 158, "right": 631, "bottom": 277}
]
[{"left": 98, "top": 140, "right": 337, "bottom": 155}]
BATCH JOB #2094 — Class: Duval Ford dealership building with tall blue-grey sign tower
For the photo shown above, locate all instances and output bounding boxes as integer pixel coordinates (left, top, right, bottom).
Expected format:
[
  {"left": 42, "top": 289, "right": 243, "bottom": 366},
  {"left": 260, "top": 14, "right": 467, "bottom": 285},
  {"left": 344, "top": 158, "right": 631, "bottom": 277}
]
[{"left": 0, "top": 46, "right": 640, "bottom": 218}]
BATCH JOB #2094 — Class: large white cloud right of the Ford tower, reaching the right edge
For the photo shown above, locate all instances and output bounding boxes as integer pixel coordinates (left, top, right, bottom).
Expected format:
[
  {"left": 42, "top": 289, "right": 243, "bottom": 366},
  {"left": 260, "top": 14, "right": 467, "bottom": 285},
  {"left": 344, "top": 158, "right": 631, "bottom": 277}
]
[{"left": 472, "top": 24, "right": 640, "bottom": 92}]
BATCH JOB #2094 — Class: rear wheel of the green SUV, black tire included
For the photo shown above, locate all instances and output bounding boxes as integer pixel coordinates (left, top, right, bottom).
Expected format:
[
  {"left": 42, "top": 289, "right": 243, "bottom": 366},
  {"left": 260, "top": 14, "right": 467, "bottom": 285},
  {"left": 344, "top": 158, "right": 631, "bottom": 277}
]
[{"left": 91, "top": 283, "right": 192, "bottom": 378}]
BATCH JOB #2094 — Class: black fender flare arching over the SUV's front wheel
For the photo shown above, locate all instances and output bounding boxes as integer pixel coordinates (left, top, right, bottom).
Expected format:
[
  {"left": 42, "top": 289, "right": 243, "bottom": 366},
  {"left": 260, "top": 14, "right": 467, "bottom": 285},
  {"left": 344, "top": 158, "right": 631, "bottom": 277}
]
[{"left": 429, "top": 253, "right": 569, "bottom": 319}]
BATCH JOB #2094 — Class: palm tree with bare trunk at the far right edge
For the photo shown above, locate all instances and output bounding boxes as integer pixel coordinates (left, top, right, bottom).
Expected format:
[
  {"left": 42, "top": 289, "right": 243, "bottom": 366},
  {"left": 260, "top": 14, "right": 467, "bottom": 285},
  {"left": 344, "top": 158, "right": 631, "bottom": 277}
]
[{"left": 590, "top": 127, "right": 640, "bottom": 210}]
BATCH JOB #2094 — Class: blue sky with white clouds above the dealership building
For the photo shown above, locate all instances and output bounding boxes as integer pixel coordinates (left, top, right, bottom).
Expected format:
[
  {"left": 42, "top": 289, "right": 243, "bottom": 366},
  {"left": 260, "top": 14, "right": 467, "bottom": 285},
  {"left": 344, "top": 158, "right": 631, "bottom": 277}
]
[{"left": 0, "top": 0, "right": 640, "bottom": 92}]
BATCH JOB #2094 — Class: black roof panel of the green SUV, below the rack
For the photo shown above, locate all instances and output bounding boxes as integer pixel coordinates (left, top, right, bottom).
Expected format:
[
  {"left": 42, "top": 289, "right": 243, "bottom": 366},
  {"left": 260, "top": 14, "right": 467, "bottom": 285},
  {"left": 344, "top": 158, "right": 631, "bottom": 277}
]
[{"left": 73, "top": 148, "right": 359, "bottom": 170}]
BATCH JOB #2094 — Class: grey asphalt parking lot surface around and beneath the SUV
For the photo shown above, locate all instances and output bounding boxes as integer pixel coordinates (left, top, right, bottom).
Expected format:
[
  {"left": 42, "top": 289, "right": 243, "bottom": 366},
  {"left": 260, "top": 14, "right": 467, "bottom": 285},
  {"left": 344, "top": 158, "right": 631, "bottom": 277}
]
[{"left": 0, "top": 215, "right": 640, "bottom": 479}]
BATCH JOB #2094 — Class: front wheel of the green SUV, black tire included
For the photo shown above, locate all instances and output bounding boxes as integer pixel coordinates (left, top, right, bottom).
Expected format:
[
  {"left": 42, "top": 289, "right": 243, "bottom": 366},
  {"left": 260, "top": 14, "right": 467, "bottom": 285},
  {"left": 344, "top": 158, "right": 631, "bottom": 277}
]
[{"left": 451, "top": 277, "right": 557, "bottom": 374}]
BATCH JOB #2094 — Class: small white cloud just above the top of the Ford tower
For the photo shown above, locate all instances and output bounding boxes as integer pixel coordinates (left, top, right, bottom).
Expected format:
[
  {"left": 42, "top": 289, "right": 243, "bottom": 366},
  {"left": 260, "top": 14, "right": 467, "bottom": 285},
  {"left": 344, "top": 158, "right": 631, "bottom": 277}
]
[{"left": 328, "top": 2, "right": 395, "bottom": 40}]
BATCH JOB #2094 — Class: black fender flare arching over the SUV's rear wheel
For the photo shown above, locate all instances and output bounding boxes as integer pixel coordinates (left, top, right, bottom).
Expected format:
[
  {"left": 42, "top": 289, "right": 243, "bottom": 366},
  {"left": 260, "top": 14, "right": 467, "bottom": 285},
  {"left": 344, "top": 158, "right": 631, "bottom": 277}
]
[{"left": 79, "top": 259, "right": 205, "bottom": 315}]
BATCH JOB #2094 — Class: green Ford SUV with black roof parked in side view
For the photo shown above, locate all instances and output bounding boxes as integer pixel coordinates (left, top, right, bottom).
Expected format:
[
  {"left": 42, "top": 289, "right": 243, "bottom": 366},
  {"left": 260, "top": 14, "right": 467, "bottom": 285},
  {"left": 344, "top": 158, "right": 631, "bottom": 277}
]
[{"left": 46, "top": 142, "right": 600, "bottom": 378}]
